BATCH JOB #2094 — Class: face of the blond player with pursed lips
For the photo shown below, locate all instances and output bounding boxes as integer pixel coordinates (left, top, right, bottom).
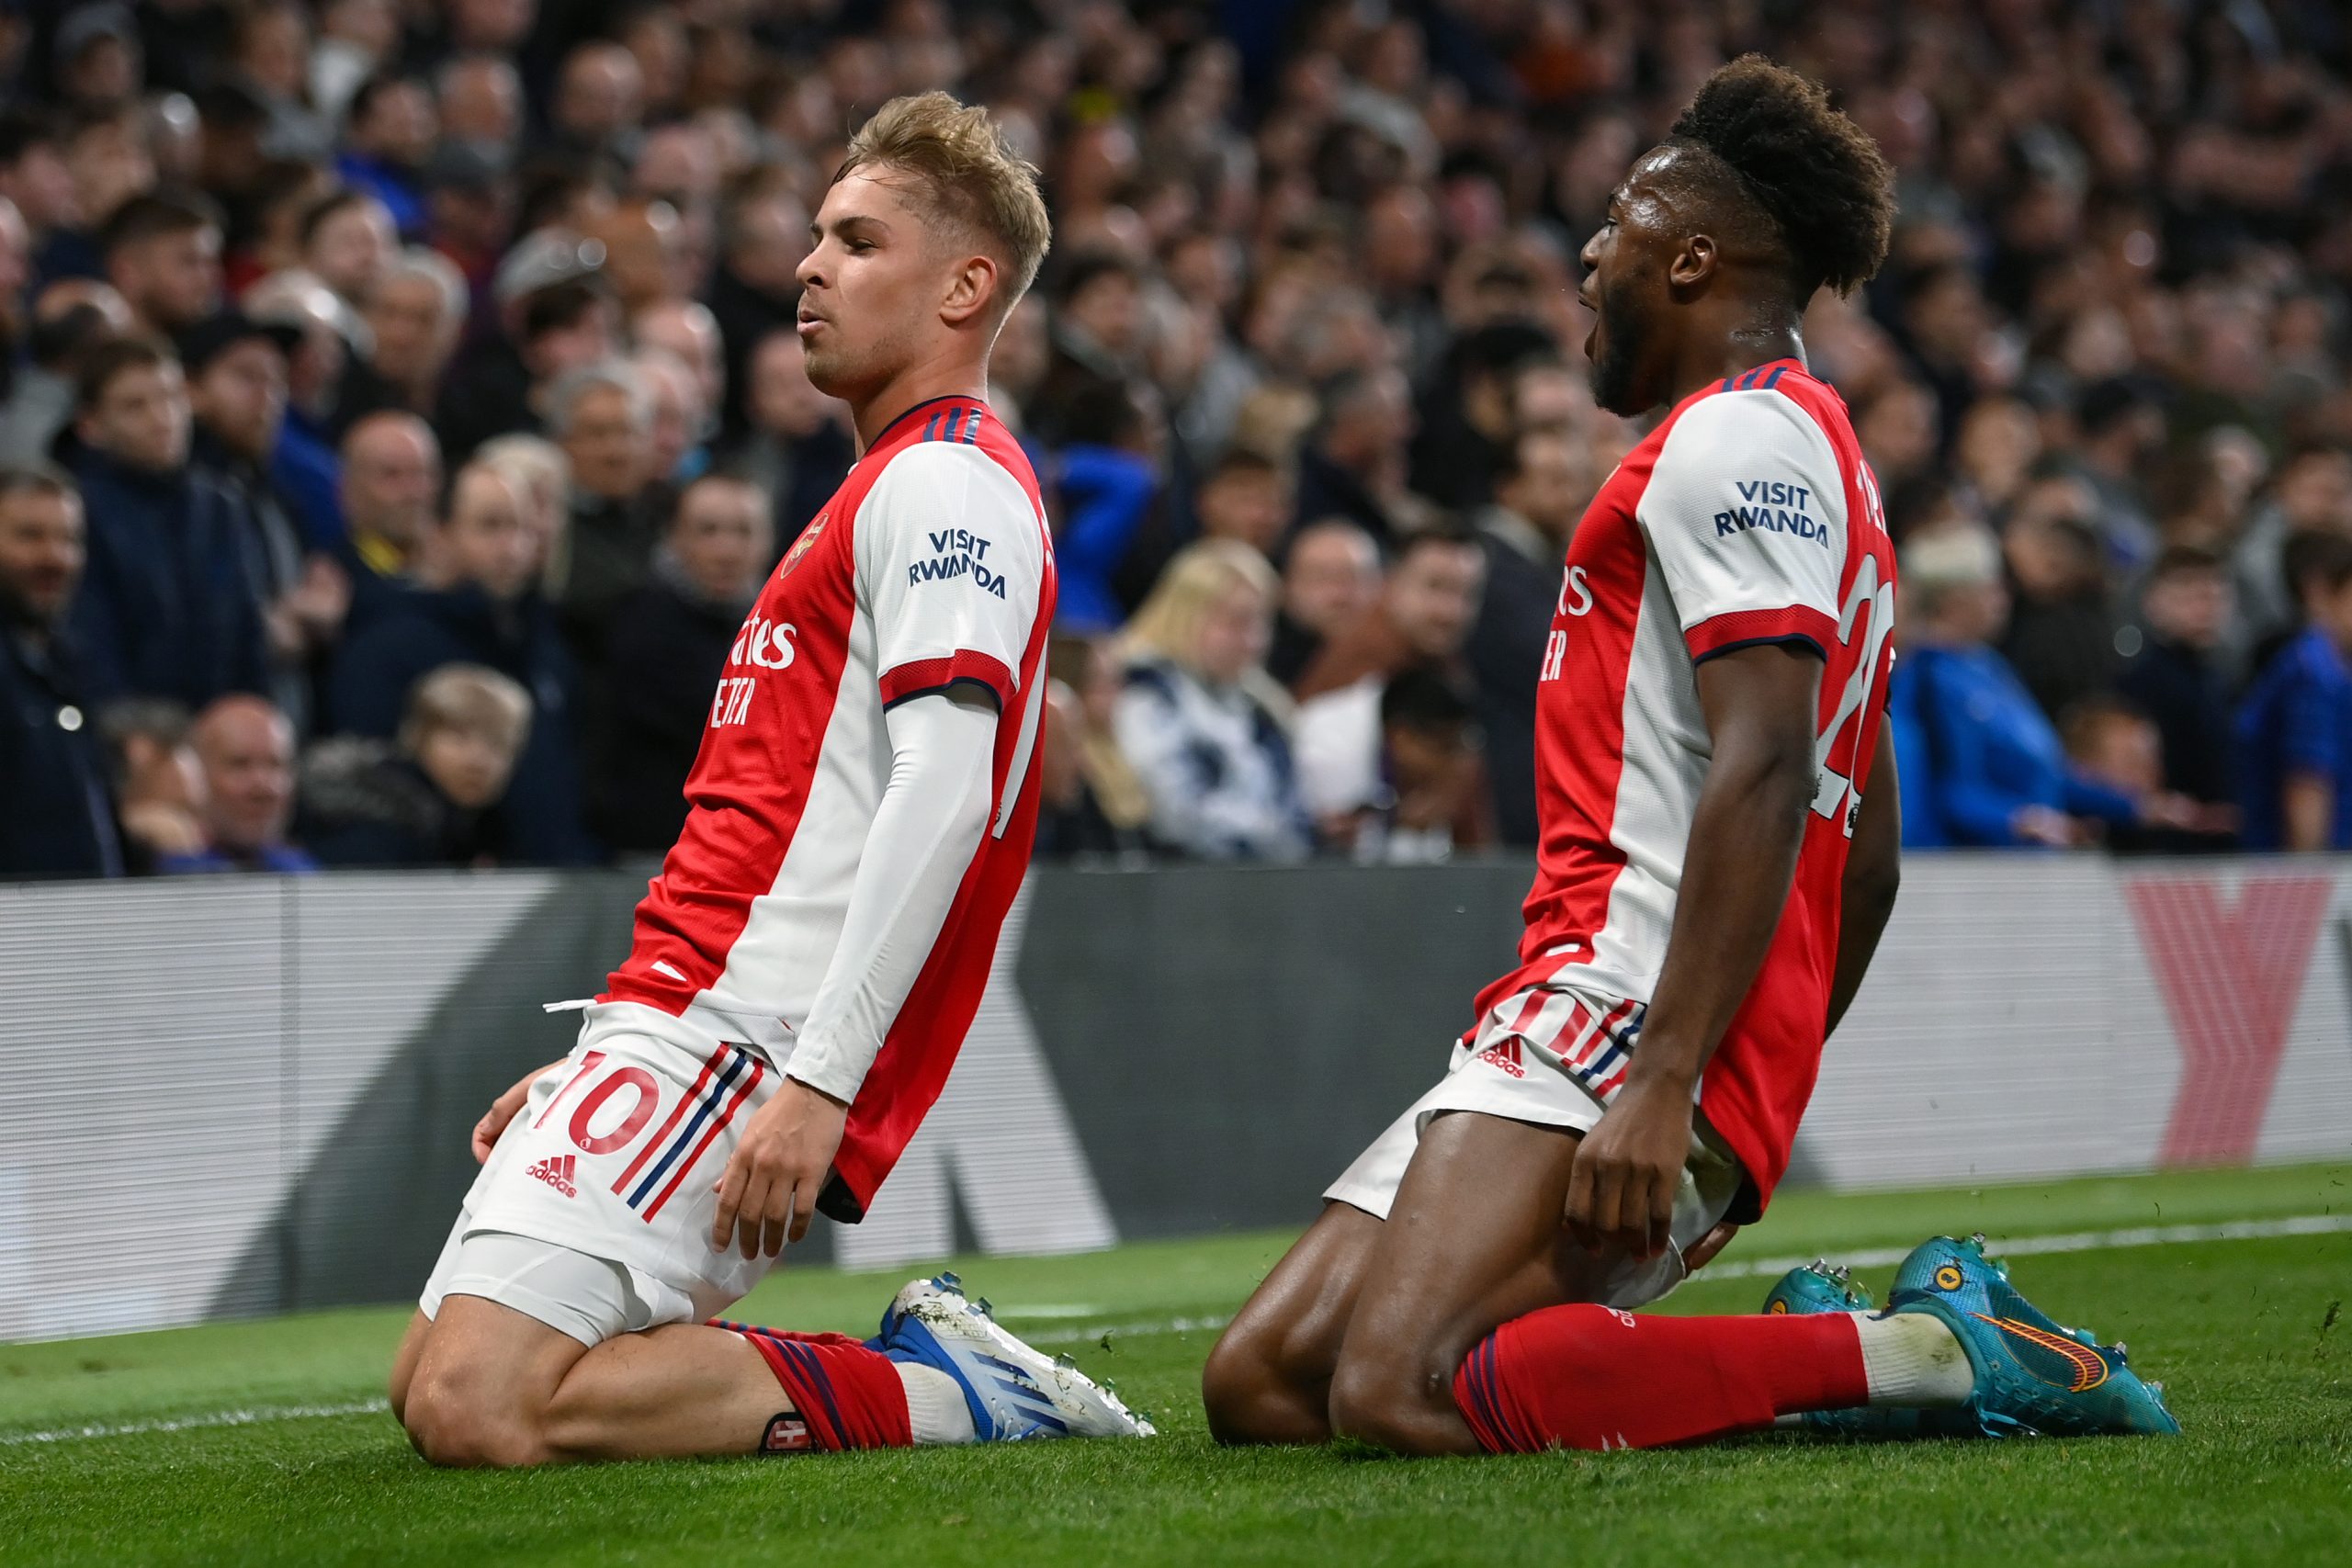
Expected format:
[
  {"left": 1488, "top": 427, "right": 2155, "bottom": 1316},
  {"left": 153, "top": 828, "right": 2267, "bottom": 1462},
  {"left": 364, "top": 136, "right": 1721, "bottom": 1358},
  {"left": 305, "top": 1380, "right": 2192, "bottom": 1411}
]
[{"left": 799, "top": 169, "right": 957, "bottom": 402}]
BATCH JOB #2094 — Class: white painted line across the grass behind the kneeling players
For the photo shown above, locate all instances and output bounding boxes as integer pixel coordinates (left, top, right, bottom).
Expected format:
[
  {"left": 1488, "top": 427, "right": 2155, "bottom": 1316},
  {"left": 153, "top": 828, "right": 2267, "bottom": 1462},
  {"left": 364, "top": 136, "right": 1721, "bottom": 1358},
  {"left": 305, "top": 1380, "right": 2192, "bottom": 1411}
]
[{"left": 0, "top": 1213, "right": 2352, "bottom": 1448}]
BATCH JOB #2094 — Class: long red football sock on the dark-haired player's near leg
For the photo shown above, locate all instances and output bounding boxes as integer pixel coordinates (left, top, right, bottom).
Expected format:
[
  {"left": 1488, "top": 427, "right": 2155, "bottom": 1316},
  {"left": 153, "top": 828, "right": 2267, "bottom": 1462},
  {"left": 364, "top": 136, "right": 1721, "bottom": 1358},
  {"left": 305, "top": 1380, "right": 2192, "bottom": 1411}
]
[{"left": 1453, "top": 1304, "right": 1870, "bottom": 1453}]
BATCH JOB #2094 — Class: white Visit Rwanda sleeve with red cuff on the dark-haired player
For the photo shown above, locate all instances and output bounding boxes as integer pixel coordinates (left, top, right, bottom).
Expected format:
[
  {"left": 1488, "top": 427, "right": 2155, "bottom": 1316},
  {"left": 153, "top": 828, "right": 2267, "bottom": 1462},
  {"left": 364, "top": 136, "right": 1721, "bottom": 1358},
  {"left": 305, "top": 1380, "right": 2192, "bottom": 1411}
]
[{"left": 1634, "top": 390, "right": 1847, "bottom": 660}]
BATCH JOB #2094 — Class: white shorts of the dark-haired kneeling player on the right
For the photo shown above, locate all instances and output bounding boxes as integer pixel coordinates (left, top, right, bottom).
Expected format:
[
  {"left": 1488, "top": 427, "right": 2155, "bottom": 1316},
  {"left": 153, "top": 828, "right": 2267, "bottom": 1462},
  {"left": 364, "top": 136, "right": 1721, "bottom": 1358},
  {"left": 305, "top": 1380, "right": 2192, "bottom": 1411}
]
[{"left": 1324, "top": 987, "right": 1743, "bottom": 1312}]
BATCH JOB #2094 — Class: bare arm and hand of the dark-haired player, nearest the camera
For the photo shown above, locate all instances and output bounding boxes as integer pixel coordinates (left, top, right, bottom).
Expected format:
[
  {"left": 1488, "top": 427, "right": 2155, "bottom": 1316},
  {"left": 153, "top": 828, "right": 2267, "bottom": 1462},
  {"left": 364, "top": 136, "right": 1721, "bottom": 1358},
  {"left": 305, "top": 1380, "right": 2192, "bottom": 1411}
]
[{"left": 1566, "top": 642, "right": 1823, "bottom": 1258}]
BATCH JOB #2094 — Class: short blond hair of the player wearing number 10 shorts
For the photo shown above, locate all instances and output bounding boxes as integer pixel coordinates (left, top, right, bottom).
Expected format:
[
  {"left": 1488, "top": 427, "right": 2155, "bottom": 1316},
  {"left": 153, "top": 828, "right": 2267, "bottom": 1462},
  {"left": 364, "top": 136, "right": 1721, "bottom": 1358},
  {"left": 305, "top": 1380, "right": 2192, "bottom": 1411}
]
[{"left": 832, "top": 92, "right": 1054, "bottom": 322}]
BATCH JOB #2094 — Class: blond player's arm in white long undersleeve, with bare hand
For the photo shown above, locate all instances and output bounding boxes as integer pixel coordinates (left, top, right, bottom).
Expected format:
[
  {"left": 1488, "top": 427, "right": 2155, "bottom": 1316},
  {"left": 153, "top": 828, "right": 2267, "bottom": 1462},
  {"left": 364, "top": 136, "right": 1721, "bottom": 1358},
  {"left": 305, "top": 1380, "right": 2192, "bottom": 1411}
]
[{"left": 710, "top": 682, "right": 997, "bottom": 1258}]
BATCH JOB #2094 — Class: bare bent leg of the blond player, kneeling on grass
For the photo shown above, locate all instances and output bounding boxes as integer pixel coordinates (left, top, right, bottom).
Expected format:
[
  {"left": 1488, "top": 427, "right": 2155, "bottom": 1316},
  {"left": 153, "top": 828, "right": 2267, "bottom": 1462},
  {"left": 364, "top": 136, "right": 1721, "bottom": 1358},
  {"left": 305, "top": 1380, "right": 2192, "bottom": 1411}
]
[{"left": 393, "top": 1295, "right": 790, "bottom": 1464}]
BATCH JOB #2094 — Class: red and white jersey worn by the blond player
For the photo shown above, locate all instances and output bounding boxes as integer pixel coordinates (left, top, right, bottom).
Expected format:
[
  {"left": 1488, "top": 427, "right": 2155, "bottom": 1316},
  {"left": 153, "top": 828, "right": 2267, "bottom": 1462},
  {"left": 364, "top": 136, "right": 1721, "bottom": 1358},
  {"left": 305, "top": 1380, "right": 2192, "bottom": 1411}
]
[{"left": 602, "top": 398, "right": 1054, "bottom": 1211}]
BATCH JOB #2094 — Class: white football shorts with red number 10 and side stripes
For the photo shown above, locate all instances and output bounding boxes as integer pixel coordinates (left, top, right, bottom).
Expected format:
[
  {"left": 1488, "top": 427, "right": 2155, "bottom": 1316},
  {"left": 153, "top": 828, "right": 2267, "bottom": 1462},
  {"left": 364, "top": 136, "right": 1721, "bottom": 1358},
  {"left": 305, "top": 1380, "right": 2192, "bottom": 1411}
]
[{"left": 419, "top": 1001, "right": 781, "bottom": 1345}]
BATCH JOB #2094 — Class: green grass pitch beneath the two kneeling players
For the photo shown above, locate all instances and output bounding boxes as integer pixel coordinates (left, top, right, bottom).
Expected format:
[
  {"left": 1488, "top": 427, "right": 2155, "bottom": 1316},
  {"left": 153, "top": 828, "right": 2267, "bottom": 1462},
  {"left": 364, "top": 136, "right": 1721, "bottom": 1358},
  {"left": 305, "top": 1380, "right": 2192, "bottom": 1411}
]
[{"left": 0, "top": 1166, "right": 2352, "bottom": 1568}]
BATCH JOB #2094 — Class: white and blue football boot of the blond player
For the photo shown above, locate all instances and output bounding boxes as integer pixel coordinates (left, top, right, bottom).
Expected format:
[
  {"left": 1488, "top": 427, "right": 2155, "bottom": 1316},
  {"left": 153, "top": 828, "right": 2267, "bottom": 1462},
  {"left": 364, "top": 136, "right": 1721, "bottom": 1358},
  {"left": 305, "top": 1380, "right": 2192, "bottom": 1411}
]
[{"left": 865, "top": 1274, "right": 1158, "bottom": 1443}]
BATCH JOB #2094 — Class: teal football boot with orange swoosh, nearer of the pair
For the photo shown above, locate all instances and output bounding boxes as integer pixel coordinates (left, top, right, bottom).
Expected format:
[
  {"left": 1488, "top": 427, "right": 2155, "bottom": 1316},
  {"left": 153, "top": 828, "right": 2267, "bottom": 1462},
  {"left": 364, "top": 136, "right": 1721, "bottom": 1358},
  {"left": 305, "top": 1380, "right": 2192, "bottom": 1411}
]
[{"left": 1886, "top": 1236, "right": 2180, "bottom": 1437}]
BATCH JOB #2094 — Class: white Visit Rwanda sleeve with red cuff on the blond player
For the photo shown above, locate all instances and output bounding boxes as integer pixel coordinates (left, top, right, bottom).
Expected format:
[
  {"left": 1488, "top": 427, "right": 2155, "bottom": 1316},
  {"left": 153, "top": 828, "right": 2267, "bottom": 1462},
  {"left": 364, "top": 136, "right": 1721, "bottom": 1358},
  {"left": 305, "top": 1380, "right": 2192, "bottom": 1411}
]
[{"left": 854, "top": 442, "right": 1045, "bottom": 712}]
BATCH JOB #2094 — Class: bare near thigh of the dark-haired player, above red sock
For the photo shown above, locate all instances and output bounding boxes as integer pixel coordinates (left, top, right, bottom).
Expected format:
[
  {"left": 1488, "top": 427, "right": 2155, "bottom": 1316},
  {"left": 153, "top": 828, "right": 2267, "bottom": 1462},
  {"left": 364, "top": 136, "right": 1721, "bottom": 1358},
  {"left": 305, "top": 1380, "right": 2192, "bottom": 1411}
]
[{"left": 1331, "top": 1112, "right": 1580, "bottom": 1429}]
